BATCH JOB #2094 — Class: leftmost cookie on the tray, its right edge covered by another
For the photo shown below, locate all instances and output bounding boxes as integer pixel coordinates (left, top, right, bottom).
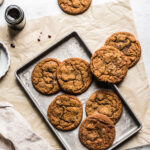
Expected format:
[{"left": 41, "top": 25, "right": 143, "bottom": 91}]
[{"left": 32, "top": 58, "right": 60, "bottom": 95}]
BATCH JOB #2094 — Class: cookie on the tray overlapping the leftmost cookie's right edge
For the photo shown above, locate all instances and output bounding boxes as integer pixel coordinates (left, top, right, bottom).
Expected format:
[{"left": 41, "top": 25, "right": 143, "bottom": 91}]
[{"left": 57, "top": 58, "right": 92, "bottom": 94}]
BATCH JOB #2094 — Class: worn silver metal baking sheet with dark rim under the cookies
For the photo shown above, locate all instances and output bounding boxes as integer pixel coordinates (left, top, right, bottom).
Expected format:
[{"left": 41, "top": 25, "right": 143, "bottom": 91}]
[{"left": 16, "top": 32, "right": 141, "bottom": 150}]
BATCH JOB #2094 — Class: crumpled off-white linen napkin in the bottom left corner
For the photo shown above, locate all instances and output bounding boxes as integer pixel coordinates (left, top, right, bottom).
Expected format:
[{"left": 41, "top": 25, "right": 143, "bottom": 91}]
[{"left": 0, "top": 102, "right": 53, "bottom": 150}]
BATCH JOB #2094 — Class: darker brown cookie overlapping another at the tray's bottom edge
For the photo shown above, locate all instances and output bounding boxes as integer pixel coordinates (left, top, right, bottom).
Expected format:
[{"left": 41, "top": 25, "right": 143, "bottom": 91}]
[{"left": 79, "top": 114, "right": 116, "bottom": 150}]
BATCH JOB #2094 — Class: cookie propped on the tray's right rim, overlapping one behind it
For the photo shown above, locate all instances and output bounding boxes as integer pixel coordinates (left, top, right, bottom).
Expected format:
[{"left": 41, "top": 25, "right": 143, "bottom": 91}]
[{"left": 91, "top": 46, "right": 128, "bottom": 83}]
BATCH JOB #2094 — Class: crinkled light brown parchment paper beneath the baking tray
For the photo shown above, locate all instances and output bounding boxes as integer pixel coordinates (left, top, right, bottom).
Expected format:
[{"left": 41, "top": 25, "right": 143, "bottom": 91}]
[{"left": 0, "top": 0, "right": 150, "bottom": 150}]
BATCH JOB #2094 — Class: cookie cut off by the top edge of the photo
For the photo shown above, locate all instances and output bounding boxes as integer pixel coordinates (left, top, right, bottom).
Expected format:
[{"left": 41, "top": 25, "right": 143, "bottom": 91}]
[{"left": 58, "top": 0, "right": 92, "bottom": 15}]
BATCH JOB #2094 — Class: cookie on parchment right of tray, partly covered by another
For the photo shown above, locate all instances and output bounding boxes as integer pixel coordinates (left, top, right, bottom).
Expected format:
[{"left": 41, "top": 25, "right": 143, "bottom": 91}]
[{"left": 105, "top": 32, "right": 141, "bottom": 68}]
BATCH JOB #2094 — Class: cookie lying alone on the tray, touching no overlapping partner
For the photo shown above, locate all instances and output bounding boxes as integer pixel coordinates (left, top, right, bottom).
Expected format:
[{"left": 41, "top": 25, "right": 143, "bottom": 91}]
[{"left": 48, "top": 94, "right": 83, "bottom": 131}]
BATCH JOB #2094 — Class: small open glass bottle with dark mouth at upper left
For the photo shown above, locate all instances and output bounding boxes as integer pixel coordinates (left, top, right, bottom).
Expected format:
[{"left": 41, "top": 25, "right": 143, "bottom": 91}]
[{"left": 5, "top": 5, "right": 26, "bottom": 30}]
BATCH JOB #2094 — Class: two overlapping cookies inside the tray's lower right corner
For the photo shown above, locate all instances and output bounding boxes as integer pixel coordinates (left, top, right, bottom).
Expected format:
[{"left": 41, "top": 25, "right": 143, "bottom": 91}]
[{"left": 79, "top": 89, "right": 122, "bottom": 150}]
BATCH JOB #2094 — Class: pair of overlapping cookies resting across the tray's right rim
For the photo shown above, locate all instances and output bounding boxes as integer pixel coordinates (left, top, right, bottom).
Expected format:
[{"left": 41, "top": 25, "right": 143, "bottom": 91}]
[{"left": 91, "top": 32, "right": 141, "bottom": 84}]
